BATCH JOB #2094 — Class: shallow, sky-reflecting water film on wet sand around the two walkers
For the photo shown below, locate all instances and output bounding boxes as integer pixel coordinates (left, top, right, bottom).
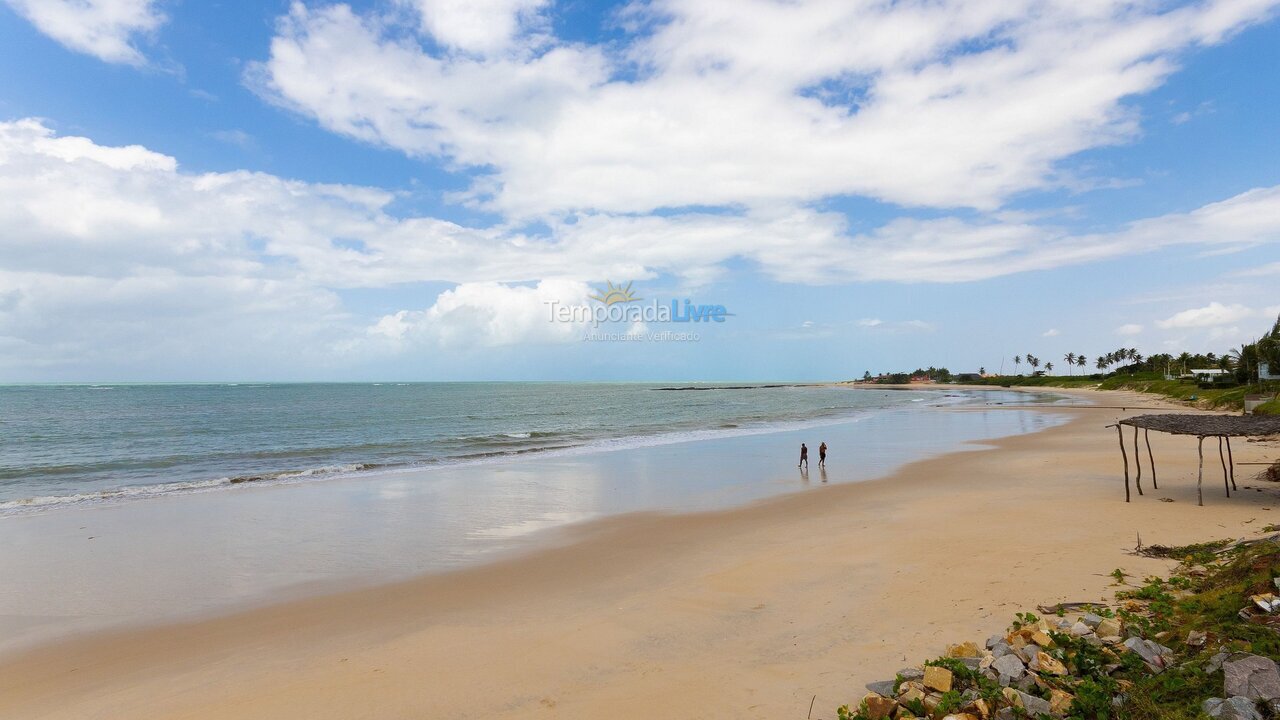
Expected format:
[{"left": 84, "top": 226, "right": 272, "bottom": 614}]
[{"left": 0, "top": 389, "right": 1065, "bottom": 648}]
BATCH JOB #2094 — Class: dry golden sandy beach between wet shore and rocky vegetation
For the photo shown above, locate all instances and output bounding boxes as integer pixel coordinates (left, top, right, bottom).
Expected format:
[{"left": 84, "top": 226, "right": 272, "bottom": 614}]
[{"left": 0, "top": 392, "right": 1280, "bottom": 720}]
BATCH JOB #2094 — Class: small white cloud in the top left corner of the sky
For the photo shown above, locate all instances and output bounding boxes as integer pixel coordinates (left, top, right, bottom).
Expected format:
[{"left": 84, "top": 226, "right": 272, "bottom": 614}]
[{"left": 5, "top": 0, "right": 165, "bottom": 65}]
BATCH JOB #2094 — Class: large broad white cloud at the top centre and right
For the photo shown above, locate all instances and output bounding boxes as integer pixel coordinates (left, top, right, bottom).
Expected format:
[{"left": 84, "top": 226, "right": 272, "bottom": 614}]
[{"left": 252, "top": 0, "right": 1276, "bottom": 218}]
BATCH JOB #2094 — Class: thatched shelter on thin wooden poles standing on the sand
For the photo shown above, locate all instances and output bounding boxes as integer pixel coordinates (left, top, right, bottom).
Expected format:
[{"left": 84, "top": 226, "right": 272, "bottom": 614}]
[{"left": 1107, "top": 413, "right": 1280, "bottom": 505}]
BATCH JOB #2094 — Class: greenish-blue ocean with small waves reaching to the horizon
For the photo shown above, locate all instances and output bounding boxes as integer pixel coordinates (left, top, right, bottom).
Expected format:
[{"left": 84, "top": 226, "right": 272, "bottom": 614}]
[{"left": 0, "top": 383, "right": 983, "bottom": 514}]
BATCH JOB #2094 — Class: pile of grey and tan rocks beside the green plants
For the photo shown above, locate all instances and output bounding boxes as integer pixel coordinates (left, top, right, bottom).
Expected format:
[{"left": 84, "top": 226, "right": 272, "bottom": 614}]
[{"left": 844, "top": 612, "right": 1146, "bottom": 720}]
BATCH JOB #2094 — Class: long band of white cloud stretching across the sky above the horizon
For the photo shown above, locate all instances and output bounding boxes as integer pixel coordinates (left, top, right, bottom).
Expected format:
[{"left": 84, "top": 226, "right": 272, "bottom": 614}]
[{"left": 0, "top": 119, "right": 1280, "bottom": 368}]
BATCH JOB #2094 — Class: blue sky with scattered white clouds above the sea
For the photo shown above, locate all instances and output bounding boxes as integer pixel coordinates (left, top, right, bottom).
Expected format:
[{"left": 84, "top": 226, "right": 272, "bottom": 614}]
[{"left": 0, "top": 0, "right": 1280, "bottom": 382}]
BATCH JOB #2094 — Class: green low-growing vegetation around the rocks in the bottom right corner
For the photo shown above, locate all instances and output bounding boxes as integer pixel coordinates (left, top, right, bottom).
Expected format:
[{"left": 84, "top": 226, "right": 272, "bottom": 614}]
[{"left": 838, "top": 536, "right": 1280, "bottom": 720}]
